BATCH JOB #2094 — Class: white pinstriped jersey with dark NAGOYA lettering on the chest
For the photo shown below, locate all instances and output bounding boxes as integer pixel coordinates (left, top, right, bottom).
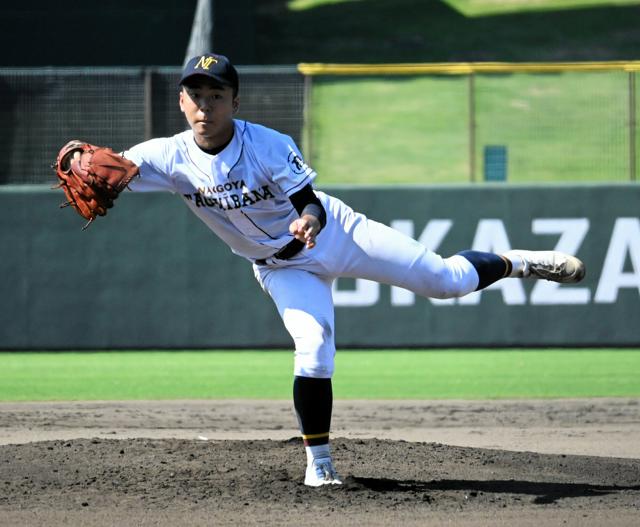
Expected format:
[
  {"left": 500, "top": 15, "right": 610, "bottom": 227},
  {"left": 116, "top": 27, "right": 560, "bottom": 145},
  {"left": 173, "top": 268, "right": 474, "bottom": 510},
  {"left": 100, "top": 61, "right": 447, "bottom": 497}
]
[{"left": 124, "top": 120, "right": 316, "bottom": 259}]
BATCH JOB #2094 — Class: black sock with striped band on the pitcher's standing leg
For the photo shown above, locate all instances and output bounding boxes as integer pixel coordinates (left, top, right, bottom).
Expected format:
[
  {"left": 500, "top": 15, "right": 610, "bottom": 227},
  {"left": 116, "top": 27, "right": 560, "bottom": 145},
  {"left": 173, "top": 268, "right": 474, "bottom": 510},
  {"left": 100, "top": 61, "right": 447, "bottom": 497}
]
[{"left": 293, "top": 377, "right": 333, "bottom": 446}]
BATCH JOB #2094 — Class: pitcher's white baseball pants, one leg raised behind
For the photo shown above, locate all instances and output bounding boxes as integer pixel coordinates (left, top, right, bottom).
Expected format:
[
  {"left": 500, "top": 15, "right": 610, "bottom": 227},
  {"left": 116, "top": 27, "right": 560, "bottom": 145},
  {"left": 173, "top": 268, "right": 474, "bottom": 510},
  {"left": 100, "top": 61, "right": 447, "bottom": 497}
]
[{"left": 254, "top": 192, "right": 479, "bottom": 378}]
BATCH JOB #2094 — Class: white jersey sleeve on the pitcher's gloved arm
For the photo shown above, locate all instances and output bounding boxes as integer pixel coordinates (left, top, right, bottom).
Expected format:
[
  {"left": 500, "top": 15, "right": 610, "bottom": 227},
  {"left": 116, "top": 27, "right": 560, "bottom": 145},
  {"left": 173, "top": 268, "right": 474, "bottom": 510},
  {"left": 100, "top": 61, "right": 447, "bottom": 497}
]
[{"left": 123, "top": 138, "right": 176, "bottom": 192}]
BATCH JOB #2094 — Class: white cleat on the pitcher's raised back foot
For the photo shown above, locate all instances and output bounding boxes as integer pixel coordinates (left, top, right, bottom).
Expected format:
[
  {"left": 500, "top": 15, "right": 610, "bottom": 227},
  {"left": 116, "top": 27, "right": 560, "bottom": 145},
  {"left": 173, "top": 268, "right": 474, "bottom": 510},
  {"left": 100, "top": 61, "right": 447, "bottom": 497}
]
[{"left": 504, "top": 249, "right": 586, "bottom": 284}]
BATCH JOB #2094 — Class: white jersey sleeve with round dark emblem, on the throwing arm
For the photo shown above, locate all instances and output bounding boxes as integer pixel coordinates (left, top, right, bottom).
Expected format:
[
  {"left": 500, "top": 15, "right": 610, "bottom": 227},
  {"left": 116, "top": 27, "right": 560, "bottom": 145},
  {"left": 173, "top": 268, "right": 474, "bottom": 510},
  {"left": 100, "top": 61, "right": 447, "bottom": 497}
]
[{"left": 270, "top": 135, "right": 316, "bottom": 196}]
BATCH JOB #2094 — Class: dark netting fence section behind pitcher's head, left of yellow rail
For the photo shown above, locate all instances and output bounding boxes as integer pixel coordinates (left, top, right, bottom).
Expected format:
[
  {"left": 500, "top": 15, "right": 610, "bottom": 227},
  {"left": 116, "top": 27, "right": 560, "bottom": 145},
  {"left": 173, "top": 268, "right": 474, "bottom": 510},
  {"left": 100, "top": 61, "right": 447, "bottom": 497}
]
[{"left": 0, "top": 66, "right": 304, "bottom": 184}]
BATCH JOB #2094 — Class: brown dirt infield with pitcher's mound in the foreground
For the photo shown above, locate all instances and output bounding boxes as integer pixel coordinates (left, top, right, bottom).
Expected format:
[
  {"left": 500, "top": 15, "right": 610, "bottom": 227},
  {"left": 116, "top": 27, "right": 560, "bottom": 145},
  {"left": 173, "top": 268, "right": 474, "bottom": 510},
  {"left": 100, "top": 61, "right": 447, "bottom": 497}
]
[{"left": 0, "top": 399, "right": 640, "bottom": 527}]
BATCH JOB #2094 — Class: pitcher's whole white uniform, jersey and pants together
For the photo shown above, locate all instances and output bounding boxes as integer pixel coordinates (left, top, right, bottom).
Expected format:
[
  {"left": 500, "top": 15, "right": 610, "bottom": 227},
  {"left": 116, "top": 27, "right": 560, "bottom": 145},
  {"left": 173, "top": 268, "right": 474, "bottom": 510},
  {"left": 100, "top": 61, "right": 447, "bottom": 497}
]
[{"left": 124, "top": 120, "right": 478, "bottom": 378}]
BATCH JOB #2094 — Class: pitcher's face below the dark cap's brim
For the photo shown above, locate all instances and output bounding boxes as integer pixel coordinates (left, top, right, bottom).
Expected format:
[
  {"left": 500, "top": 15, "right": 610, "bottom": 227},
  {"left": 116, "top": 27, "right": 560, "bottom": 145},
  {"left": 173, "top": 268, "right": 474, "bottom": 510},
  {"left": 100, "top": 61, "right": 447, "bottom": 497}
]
[{"left": 180, "top": 82, "right": 238, "bottom": 149}]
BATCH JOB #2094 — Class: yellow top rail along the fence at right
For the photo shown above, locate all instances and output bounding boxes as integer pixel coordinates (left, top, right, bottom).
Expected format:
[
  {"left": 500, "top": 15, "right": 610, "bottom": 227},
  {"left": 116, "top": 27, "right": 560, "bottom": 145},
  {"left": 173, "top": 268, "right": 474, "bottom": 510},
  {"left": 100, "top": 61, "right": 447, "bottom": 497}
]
[{"left": 298, "top": 60, "right": 640, "bottom": 75}]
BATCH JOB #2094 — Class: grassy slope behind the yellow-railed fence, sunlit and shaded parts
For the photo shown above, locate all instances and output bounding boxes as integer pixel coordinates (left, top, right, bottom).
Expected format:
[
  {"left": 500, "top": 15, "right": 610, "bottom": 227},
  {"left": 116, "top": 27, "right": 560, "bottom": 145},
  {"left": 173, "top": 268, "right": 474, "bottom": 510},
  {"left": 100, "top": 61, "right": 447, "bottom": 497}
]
[{"left": 268, "top": 0, "right": 640, "bottom": 184}]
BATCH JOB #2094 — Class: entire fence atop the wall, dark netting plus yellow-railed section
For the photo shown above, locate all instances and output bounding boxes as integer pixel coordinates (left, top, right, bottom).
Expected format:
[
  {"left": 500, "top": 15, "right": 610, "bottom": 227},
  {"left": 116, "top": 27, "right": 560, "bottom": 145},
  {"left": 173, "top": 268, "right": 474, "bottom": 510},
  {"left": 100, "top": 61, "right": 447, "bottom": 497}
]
[{"left": 0, "top": 62, "right": 640, "bottom": 184}]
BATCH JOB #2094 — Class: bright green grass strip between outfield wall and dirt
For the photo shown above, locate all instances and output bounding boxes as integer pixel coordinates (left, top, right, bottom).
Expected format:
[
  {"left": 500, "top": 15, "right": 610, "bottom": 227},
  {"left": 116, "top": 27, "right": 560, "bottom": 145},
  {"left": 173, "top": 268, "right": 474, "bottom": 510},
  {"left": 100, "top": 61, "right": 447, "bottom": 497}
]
[{"left": 0, "top": 349, "right": 640, "bottom": 401}]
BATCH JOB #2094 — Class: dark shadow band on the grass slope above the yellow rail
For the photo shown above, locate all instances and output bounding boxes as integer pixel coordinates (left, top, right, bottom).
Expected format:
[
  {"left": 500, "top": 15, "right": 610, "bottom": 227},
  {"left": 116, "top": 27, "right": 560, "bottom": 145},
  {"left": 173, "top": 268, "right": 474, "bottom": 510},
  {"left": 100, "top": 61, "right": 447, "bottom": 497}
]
[{"left": 254, "top": 0, "right": 640, "bottom": 64}]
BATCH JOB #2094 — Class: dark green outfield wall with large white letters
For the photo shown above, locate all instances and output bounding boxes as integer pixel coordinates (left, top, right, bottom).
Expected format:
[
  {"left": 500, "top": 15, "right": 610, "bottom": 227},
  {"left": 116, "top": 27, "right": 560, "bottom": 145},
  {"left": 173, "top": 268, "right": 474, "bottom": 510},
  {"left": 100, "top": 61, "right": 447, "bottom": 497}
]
[{"left": 0, "top": 184, "right": 640, "bottom": 349}]
